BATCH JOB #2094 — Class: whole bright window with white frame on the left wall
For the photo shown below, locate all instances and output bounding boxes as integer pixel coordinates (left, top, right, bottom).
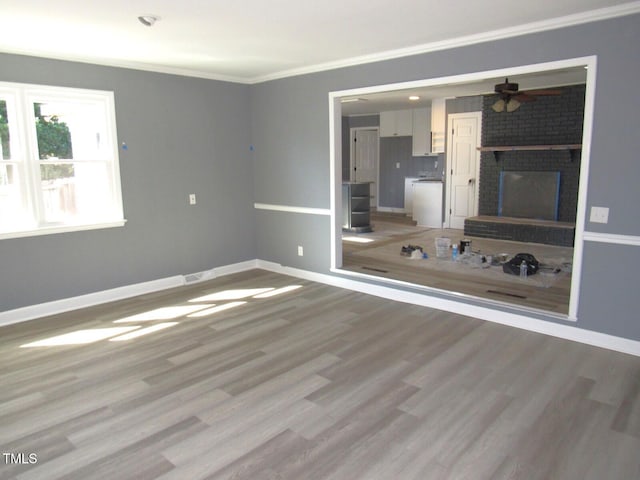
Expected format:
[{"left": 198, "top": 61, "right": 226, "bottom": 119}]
[{"left": 0, "top": 83, "right": 124, "bottom": 238}]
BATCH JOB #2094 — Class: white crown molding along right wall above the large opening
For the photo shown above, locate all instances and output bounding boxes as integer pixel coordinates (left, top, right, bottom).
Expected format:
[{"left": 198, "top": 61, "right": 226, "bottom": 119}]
[{"left": 247, "top": 1, "right": 640, "bottom": 84}]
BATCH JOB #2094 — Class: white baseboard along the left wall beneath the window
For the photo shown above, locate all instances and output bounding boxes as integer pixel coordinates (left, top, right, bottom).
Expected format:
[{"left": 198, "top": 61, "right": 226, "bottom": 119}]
[{"left": 0, "top": 260, "right": 257, "bottom": 327}]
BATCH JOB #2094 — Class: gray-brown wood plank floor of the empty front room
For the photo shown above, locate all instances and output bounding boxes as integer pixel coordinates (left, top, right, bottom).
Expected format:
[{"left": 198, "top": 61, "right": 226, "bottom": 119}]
[{"left": 0, "top": 270, "right": 640, "bottom": 480}]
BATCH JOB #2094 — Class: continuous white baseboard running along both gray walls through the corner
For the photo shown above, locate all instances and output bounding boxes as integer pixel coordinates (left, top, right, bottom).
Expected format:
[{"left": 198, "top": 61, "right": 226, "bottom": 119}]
[{"left": 0, "top": 259, "right": 640, "bottom": 356}]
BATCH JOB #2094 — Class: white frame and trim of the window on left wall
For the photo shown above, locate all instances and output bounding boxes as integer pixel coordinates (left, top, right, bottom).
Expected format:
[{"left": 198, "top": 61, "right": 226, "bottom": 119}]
[{"left": 0, "top": 82, "right": 126, "bottom": 240}]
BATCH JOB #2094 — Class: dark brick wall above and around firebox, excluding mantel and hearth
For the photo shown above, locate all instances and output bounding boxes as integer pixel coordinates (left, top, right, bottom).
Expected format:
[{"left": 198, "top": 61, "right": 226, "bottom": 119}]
[{"left": 478, "top": 85, "right": 585, "bottom": 222}]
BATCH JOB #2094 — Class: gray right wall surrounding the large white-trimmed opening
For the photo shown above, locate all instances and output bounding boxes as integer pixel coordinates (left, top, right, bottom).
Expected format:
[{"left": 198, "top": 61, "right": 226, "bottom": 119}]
[{"left": 251, "top": 15, "right": 640, "bottom": 340}]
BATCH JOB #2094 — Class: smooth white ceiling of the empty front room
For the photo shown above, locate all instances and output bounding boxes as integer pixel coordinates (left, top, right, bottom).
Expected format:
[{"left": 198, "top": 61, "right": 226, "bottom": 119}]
[{"left": 0, "top": 0, "right": 640, "bottom": 83}]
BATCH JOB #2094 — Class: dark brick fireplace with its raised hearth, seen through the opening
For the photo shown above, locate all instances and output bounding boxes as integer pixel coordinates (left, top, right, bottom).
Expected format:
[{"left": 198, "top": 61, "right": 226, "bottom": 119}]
[{"left": 464, "top": 85, "right": 585, "bottom": 246}]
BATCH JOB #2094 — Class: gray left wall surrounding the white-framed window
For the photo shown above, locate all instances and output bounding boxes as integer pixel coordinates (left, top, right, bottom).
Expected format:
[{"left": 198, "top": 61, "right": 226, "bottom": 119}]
[{"left": 0, "top": 54, "right": 256, "bottom": 311}]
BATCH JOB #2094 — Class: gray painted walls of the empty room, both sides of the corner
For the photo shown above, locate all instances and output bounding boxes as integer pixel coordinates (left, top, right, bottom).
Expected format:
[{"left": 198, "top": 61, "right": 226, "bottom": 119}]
[{"left": 0, "top": 15, "right": 640, "bottom": 340}]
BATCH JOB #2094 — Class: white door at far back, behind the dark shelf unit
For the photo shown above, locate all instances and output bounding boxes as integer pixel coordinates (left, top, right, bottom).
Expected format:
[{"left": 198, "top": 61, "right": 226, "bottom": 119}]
[{"left": 350, "top": 128, "right": 379, "bottom": 207}]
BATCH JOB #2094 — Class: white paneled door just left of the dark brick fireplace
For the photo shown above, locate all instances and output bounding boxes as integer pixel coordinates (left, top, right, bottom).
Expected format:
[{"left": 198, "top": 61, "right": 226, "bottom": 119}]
[{"left": 445, "top": 112, "right": 482, "bottom": 229}]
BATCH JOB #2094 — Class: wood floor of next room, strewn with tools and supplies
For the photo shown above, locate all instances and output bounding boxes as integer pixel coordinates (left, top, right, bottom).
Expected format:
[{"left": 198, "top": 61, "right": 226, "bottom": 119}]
[{"left": 342, "top": 215, "right": 573, "bottom": 315}]
